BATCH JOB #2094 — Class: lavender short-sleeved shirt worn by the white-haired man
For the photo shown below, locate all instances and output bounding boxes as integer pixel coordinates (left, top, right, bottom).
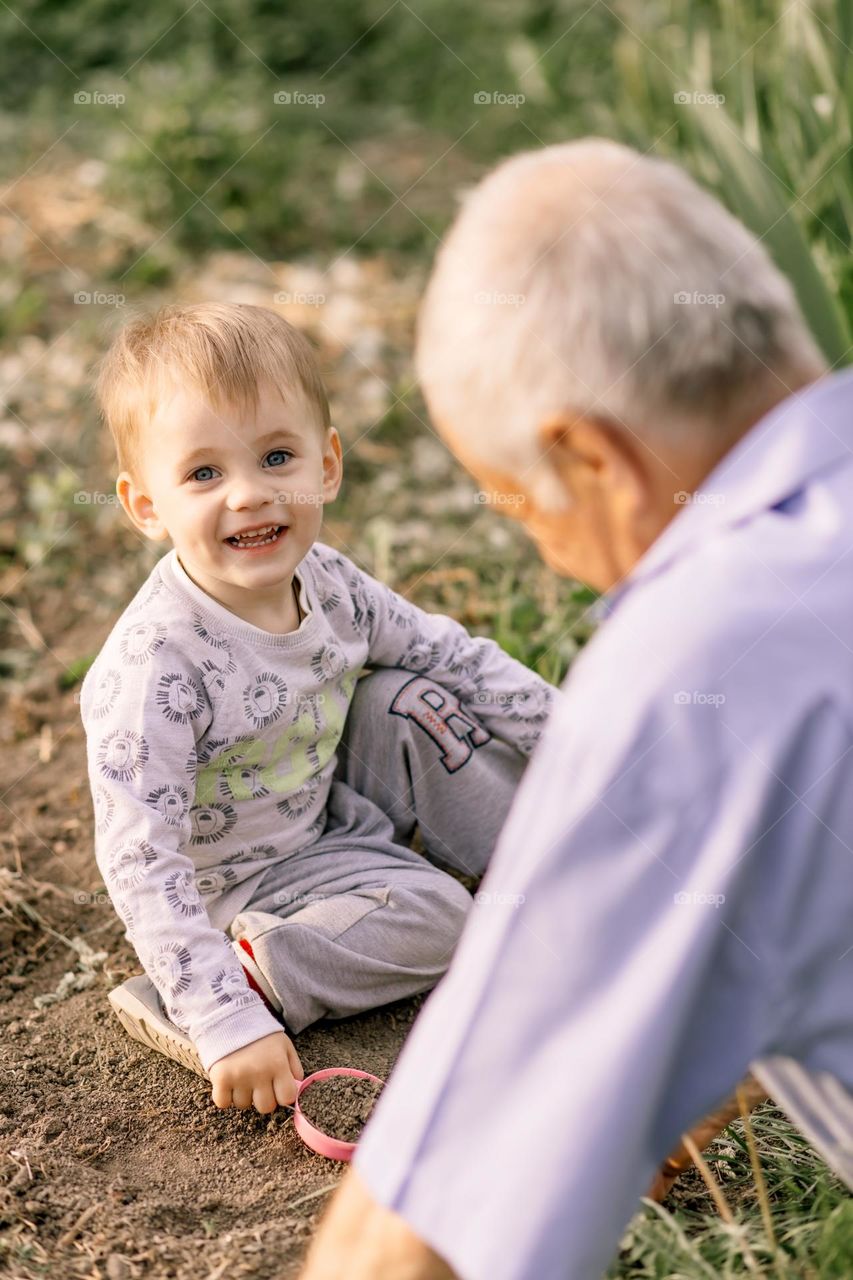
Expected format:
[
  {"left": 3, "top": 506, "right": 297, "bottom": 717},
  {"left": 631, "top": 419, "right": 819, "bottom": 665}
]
[{"left": 355, "top": 372, "right": 853, "bottom": 1280}]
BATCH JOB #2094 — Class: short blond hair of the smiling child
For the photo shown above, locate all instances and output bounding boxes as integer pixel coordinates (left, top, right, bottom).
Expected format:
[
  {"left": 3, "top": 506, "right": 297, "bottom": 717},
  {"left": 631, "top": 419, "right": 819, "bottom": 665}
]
[{"left": 96, "top": 302, "right": 330, "bottom": 477}]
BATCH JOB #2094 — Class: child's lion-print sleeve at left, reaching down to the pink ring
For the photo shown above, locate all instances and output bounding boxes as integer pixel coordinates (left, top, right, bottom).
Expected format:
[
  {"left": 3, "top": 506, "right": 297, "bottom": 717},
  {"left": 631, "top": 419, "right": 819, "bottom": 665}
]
[{"left": 81, "top": 621, "right": 282, "bottom": 1070}]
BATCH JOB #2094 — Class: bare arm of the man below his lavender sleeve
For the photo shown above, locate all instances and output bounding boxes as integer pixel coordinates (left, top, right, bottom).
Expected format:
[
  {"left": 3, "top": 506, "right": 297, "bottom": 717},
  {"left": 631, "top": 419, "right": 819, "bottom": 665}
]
[{"left": 300, "top": 1169, "right": 456, "bottom": 1280}]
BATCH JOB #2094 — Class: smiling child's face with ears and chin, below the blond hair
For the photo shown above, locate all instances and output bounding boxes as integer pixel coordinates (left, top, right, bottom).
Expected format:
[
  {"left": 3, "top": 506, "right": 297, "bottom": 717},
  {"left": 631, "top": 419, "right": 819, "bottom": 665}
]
[{"left": 119, "top": 383, "right": 341, "bottom": 630}]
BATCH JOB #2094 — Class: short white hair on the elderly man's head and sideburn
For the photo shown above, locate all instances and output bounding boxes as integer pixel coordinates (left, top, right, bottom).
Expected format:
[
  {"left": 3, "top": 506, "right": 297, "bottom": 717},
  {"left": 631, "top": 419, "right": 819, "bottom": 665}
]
[{"left": 416, "top": 138, "right": 826, "bottom": 509}]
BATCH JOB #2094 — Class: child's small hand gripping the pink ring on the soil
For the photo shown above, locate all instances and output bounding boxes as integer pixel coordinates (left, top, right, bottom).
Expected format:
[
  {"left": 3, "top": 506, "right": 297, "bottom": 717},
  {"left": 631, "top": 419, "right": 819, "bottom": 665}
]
[{"left": 210, "top": 1032, "right": 305, "bottom": 1115}]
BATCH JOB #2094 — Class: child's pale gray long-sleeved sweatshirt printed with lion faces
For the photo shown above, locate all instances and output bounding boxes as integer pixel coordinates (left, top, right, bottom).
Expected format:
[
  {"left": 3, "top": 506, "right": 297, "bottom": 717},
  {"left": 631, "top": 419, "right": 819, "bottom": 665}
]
[{"left": 81, "top": 543, "right": 557, "bottom": 1069}]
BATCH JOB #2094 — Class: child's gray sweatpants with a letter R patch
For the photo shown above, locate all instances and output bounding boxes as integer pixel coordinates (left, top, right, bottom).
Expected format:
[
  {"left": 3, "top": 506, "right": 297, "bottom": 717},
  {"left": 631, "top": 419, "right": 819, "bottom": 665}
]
[{"left": 228, "top": 668, "right": 526, "bottom": 1032}]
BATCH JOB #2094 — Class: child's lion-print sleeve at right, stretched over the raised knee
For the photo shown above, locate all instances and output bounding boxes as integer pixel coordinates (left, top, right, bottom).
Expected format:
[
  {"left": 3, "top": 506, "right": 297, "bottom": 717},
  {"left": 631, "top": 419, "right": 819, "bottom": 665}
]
[{"left": 326, "top": 557, "right": 560, "bottom": 755}]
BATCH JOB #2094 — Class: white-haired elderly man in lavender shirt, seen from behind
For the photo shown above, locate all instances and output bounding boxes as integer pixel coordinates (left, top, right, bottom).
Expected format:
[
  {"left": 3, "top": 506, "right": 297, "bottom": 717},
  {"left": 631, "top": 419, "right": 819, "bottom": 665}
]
[{"left": 297, "top": 140, "right": 853, "bottom": 1280}]
